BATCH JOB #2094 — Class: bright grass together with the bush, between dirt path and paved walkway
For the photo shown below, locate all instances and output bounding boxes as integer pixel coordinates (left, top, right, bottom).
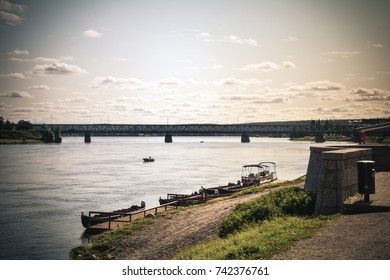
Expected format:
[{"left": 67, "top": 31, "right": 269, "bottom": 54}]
[{"left": 174, "top": 184, "right": 337, "bottom": 260}]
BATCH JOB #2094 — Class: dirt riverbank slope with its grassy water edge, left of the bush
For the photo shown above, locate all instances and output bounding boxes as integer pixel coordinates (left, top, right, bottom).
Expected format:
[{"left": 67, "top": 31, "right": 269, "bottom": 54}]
[{"left": 71, "top": 178, "right": 326, "bottom": 259}]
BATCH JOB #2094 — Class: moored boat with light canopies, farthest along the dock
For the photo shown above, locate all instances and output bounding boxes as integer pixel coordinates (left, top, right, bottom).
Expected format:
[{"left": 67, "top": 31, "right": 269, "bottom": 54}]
[{"left": 241, "top": 162, "right": 277, "bottom": 186}]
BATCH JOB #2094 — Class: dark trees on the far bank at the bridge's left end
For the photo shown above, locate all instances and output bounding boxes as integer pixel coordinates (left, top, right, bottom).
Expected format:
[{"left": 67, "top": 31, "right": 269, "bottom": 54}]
[{"left": 0, "top": 116, "right": 62, "bottom": 143}]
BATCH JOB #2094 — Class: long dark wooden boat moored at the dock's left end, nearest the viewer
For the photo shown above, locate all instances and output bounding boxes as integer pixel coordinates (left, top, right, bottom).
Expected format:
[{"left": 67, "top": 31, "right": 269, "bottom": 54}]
[{"left": 81, "top": 201, "right": 145, "bottom": 228}]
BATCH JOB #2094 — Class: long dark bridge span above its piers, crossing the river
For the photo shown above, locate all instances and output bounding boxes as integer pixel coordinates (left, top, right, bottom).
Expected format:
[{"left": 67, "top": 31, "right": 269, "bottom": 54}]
[{"left": 33, "top": 121, "right": 356, "bottom": 137}]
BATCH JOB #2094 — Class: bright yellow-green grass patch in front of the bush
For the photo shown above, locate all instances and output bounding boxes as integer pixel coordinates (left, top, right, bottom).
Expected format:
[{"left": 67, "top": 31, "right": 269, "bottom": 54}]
[{"left": 174, "top": 216, "right": 335, "bottom": 260}]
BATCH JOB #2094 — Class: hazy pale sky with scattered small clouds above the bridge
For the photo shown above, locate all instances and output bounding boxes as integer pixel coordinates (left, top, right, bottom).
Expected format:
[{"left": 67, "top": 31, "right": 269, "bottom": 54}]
[{"left": 0, "top": 0, "right": 390, "bottom": 124}]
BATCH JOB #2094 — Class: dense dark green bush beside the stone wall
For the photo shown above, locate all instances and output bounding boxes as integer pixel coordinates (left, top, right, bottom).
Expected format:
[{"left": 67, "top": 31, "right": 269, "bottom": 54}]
[{"left": 219, "top": 188, "right": 315, "bottom": 237}]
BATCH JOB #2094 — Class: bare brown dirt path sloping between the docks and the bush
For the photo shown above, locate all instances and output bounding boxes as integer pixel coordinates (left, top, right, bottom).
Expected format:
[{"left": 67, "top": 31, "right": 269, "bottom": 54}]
[{"left": 118, "top": 183, "right": 294, "bottom": 260}]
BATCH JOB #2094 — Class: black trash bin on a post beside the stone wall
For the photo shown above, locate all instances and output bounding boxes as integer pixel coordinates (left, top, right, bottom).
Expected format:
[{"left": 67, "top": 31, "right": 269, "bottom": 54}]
[{"left": 357, "top": 160, "right": 375, "bottom": 194}]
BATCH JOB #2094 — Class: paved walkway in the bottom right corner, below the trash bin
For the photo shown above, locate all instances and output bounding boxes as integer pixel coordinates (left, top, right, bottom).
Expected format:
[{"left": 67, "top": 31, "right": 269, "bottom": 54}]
[{"left": 274, "top": 172, "right": 390, "bottom": 260}]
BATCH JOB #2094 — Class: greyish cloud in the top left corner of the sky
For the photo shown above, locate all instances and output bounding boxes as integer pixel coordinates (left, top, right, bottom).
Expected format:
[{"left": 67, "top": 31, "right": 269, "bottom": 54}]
[{"left": 0, "top": 0, "right": 28, "bottom": 26}]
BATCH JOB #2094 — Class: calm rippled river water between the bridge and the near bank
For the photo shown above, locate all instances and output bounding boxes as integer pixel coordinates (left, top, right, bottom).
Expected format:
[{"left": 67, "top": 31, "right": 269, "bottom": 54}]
[{"left": 0, "top": 137, "right": 348, "bottom": 260}]
